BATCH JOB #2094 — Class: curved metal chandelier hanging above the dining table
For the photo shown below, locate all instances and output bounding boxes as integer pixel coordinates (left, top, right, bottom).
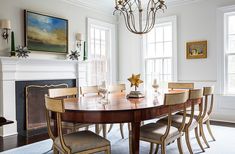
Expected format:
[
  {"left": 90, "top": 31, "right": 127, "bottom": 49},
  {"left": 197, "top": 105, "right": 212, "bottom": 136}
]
[{"left": 113, "top": 0, "right": 167, "bottom": 34}]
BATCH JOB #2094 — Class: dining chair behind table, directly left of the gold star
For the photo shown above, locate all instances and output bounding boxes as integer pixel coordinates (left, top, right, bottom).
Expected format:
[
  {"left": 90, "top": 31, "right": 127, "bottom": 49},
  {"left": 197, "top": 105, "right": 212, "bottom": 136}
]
[{"left": 104, "top": 84, "right": 126, "bottom": 139}]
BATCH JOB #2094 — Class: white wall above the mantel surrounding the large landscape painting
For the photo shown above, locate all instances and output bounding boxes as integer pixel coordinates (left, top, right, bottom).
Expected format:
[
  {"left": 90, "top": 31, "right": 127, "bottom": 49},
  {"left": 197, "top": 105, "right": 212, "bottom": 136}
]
[{"left": 0, "top": 0, "right": 116, "bottom": 59}]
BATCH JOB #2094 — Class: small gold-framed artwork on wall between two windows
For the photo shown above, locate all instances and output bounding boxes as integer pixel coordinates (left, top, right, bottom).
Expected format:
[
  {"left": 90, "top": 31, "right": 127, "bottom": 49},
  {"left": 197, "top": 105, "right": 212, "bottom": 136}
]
[{"left": 186, "top": 41, "right": 207, "bottom": 59}]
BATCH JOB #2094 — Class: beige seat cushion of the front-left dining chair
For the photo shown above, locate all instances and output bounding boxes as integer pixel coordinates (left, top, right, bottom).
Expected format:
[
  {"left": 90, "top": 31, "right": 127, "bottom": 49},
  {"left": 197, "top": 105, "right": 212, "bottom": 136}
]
[{"left": 54, "top": 131, "right": 110, "bottom": 153}]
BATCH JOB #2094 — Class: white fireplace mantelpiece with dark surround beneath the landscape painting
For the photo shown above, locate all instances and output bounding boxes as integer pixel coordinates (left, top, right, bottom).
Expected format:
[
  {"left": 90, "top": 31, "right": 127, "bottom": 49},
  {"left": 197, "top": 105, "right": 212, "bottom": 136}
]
[{"left": 0, "top": 57, "right": 79, "bottom": 137}]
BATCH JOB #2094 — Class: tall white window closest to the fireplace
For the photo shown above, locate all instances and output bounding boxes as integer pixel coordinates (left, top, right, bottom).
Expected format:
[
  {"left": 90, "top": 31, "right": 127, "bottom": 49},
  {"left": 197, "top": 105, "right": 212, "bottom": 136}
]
[{"left": 79, "top": 18, "right": 116, "bottom": 86}]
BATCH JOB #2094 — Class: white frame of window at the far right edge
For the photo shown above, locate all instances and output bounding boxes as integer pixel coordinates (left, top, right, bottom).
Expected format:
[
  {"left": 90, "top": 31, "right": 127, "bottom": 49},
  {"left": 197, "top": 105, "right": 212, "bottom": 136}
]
[{"left": 217, "top": 5, "right": 235, "bottom": 95}]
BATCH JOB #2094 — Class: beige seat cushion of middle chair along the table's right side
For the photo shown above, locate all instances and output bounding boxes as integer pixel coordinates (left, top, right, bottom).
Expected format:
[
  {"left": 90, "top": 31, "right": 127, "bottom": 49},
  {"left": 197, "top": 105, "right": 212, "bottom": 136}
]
[{"left": 158, "top": 114, "right": 198, "bottom": 130}]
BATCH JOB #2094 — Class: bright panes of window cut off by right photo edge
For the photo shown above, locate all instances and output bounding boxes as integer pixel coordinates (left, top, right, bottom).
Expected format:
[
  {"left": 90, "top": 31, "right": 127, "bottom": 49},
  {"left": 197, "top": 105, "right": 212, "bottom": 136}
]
[{"left": 224, "top": 12, "right": 235, "bottom": 94}]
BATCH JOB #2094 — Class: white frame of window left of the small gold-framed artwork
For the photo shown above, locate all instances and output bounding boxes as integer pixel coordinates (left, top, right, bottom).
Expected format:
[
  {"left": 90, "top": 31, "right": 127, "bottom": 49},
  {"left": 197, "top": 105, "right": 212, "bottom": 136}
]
[{"left": 141, "top": 16, "right": 178, "bottom": 87}]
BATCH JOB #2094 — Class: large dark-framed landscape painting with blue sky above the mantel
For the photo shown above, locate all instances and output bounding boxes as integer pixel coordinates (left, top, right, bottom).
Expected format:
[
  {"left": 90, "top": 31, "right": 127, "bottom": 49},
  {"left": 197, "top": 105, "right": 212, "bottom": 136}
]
[{"left": 24, "top": 10, "right": 68, "bottom": 53}]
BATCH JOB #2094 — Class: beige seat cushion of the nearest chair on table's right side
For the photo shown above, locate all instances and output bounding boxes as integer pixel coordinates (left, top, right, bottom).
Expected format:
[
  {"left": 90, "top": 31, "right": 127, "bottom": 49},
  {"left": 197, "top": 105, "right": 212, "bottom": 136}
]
[{"left": 140, "top": 122, "right": 180, "bottom": 141}]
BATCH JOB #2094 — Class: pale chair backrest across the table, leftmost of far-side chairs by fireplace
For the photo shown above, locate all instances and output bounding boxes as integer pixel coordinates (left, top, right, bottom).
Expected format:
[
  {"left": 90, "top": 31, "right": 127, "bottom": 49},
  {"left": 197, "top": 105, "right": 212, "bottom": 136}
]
[{"left": 48, "top": 87, "right": 78, "bottom": 98}]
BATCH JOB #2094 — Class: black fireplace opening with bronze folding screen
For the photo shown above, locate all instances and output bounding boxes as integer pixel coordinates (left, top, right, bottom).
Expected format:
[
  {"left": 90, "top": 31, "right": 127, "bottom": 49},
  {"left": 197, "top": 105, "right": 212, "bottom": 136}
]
[{"left": 15, "top": 79, "right": 76, "bottom": 136}]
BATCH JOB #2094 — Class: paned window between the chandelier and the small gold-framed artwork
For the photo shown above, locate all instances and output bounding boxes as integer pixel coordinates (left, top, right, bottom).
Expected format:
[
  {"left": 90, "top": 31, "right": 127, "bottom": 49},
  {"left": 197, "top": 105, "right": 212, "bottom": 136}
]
[{"left": 144, "top": 17, "right": 177, "bottom": 89}]
